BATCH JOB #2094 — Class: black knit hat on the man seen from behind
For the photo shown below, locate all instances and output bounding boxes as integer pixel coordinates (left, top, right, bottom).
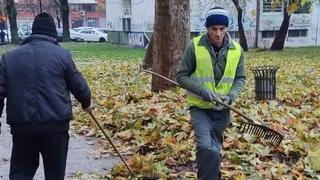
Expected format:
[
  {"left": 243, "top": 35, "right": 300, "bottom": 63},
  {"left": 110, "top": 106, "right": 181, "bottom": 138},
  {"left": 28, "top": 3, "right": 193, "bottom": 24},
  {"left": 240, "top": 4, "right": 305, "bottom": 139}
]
[{"left": 32, "top": 12, "right": 58, "bottom": 37}]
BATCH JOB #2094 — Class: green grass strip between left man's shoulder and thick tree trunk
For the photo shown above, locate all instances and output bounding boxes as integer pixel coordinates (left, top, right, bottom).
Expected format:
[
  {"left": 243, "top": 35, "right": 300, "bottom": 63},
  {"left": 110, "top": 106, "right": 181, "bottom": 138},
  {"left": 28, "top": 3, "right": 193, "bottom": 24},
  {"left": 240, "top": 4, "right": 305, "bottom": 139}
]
[{"left": 61, "top": 42, "right": 144, "bottom": 61}]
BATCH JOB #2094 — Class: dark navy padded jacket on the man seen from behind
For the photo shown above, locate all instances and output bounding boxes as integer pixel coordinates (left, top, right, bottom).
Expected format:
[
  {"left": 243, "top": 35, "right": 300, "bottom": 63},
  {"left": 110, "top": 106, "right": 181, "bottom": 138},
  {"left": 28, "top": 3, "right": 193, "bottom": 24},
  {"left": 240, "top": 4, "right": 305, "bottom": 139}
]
[{"left": 0, "top": 34, "right": 91, "bottom": 133}]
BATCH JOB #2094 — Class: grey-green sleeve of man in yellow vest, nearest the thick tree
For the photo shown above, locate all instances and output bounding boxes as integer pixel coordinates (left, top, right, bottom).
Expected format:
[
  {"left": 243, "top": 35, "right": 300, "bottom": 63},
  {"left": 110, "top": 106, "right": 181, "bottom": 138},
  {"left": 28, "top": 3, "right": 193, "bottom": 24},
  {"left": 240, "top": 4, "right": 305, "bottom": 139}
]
[{"left": 176, "top": 42, "right": 202, "bottom": 95}]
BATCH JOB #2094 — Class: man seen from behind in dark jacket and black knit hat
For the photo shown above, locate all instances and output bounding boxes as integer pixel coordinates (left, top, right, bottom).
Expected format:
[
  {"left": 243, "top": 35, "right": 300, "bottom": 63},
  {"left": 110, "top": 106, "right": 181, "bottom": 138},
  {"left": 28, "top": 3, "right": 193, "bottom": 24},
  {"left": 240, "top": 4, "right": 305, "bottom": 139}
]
[{"left": 0, "top": 13, "right": 91, "bottom": 180}]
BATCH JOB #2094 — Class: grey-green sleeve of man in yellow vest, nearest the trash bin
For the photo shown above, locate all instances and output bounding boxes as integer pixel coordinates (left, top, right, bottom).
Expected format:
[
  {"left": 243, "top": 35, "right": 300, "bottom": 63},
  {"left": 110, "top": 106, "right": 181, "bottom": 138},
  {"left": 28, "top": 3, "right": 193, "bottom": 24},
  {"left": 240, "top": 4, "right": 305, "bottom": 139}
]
[{"left": 229, "top": 51, "right": 246, "bottom": 102}]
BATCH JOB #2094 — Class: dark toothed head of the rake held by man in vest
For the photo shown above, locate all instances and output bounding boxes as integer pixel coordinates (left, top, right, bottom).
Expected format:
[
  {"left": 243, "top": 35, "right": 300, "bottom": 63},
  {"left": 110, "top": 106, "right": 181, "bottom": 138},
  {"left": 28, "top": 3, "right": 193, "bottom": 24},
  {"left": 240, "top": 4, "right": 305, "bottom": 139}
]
[{"left": 239, "top": 122, "right": 283, "bottom": 146}]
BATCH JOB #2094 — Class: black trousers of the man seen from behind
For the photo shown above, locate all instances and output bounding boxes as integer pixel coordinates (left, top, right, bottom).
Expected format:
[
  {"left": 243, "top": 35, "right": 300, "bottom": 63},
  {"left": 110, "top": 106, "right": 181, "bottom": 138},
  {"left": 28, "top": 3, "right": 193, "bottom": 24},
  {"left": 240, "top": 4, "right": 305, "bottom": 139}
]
[{"left": 9, "top": 132, "right": 69, "bottom": 180}]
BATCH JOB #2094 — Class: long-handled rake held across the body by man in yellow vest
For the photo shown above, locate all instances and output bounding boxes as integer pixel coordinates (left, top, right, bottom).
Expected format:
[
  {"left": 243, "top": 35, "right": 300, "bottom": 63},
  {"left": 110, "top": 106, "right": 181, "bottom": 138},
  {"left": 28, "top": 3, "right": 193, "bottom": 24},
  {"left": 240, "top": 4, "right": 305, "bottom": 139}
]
[{"left": 141, "top": 69, "right": 283, "bottom": 146}]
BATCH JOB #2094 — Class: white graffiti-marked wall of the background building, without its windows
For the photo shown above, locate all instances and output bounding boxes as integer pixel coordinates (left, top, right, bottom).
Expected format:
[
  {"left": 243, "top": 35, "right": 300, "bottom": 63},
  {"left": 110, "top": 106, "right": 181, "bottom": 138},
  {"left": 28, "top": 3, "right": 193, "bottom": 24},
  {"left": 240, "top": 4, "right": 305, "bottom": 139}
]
[{"left": 106, "top": 0, "right": 320, "bottom": 48}]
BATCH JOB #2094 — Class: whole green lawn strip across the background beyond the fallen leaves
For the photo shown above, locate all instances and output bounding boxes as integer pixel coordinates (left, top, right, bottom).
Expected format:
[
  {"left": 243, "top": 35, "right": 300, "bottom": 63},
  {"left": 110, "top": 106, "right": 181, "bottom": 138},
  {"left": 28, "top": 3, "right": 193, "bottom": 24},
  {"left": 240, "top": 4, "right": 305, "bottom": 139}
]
[{"left": 0, "top": 42, "right": 320, "bottom": 62}]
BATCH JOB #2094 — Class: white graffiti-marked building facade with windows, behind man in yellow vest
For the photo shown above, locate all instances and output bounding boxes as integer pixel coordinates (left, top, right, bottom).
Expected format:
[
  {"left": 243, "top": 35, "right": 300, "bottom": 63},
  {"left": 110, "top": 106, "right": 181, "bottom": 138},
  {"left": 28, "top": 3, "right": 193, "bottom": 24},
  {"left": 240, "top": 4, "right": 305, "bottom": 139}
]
[{"left": 106, "top": 0, "right": 320, "bottom": 48}]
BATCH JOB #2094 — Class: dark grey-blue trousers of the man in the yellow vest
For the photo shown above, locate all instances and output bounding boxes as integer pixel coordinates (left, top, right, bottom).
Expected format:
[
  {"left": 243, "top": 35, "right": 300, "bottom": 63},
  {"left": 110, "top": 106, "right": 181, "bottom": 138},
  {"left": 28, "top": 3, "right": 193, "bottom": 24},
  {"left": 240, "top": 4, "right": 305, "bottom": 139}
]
[{"left": 190, "top": 107, "right": 230, "bottom": 180}]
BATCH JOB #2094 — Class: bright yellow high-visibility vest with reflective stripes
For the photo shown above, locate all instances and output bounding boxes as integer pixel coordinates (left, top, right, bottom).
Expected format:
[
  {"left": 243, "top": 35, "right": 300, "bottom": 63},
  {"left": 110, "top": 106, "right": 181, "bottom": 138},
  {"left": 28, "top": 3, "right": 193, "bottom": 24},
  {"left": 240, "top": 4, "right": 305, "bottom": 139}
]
[{"left": 187, "top": 35, "right": 241, "bottom": 109}]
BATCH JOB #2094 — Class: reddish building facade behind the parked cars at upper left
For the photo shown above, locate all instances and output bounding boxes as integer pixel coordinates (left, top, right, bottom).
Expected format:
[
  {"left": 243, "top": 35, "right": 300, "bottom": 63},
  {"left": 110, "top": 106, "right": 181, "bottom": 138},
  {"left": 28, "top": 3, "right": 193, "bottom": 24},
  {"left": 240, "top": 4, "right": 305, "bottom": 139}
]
[{"left": 15, "top": 0, "right": 106, "bottom": 31}]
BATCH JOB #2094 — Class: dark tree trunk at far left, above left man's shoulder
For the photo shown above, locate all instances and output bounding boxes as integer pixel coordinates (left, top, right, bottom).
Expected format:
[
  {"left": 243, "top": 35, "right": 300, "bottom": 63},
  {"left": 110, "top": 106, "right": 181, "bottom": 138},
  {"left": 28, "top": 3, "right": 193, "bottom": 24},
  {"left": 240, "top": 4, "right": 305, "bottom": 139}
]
[{"left": 5, "top": 0, "right": 20, "bottom": 44}]
